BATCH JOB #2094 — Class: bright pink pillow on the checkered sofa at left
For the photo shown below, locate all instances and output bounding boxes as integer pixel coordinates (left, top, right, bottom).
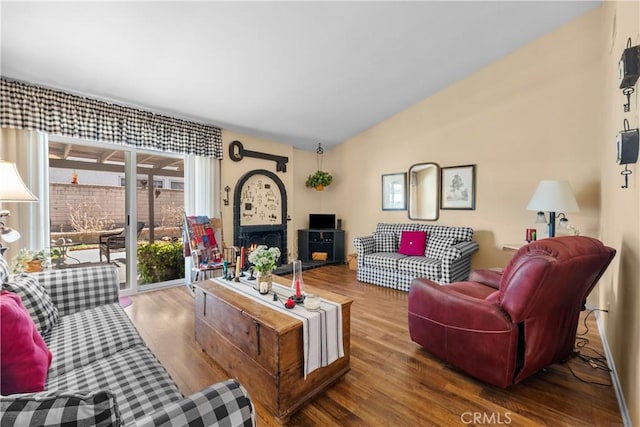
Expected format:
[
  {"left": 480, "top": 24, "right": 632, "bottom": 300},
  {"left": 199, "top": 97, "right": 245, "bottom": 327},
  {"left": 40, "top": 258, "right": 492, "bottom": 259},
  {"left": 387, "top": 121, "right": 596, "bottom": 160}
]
[{"left": 0, "top": 291, "right": 51, "bottom": 395}]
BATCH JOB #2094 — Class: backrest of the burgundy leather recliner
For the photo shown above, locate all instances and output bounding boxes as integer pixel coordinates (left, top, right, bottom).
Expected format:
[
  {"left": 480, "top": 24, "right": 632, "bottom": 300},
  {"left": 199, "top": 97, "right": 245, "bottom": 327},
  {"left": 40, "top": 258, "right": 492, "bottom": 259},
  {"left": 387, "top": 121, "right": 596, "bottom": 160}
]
[{"left": 499, "top": 236, "right": 616, "bottom": 383}]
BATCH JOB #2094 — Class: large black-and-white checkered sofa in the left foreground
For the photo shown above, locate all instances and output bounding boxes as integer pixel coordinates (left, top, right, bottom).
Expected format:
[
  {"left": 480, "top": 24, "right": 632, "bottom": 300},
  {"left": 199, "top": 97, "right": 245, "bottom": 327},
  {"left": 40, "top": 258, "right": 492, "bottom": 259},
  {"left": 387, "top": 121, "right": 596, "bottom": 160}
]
[{"left": 0, "top": 264, "right": 256, "bottom": 427}]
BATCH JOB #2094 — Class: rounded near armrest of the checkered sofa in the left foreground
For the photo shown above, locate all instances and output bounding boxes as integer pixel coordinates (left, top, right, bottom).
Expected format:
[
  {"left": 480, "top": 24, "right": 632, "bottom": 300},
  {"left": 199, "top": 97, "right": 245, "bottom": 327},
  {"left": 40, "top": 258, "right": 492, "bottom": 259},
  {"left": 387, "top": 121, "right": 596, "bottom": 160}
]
[{"left": 136, "top": 380, "right": 256, "bottom": 427}]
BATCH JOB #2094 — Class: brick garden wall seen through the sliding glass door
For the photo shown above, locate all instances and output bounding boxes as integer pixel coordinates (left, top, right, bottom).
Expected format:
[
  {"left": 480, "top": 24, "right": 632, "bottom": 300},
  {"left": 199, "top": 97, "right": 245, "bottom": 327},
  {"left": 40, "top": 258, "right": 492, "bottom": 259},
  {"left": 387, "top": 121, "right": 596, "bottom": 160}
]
[{"left": 49, "top": 184, "right": 184, "bottom": 233}]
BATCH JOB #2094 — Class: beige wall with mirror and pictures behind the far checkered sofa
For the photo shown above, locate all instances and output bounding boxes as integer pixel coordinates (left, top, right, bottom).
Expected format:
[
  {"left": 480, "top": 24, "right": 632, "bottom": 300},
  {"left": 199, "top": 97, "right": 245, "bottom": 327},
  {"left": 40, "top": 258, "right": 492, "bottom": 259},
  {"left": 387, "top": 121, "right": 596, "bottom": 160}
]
[{"left": 330, "top": 6, "right": 602, "bottom": 267}]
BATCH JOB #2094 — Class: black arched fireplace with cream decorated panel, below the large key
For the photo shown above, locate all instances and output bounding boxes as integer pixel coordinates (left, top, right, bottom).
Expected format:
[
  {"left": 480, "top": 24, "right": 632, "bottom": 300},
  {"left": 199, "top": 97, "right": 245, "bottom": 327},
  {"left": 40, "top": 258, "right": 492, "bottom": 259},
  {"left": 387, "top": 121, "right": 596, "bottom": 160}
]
[{"left": 233, "top": 169, "right": 288, "bottom": 265}]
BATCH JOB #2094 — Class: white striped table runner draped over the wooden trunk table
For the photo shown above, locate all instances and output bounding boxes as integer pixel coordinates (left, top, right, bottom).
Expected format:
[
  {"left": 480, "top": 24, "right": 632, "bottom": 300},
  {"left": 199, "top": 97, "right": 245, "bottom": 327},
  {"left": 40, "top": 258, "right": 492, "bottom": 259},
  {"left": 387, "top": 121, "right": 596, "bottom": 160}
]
[{"left": 211, "top": 277, "right": 344, "bottom": 379}]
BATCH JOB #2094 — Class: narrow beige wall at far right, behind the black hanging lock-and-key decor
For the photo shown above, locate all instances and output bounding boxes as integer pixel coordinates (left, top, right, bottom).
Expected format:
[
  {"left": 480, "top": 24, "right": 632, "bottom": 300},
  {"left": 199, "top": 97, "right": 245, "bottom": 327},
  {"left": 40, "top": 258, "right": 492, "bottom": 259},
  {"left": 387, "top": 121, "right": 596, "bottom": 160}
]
[{"left": 597, "top": 2, "right": 640, "bottom": 425}]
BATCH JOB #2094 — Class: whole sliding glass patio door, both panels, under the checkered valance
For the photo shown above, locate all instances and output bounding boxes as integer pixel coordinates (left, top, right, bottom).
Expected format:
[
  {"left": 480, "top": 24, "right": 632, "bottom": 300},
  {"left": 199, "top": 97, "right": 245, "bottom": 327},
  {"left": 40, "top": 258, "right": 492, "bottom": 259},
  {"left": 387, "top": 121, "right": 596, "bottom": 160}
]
[{"left": 49, "top": 137, "right": 184, "bottom": 295}]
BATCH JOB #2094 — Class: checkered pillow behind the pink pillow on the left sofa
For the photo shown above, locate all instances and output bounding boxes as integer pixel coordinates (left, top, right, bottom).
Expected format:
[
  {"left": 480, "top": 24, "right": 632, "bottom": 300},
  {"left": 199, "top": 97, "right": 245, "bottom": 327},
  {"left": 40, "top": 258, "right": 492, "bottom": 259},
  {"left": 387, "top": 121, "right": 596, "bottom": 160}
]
[{"left": 2, "top": 273, "right": 59, "bottom": 334}]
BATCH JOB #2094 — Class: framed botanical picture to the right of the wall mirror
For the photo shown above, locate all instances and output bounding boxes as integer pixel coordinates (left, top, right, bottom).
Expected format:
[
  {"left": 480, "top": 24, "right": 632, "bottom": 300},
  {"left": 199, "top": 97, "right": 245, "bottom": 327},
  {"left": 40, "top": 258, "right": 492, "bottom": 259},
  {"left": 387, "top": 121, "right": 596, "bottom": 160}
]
[{"left": 440, "top": 165, "right": 476, "bottom": 210}]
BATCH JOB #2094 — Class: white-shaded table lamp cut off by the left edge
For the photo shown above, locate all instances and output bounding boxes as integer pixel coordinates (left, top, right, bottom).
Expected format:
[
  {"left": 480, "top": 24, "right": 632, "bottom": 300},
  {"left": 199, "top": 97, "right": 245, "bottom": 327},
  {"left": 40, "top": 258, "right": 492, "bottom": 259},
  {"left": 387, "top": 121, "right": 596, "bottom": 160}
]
[{"left": 0, "top": 160, "right": 38, "bottom": 256}]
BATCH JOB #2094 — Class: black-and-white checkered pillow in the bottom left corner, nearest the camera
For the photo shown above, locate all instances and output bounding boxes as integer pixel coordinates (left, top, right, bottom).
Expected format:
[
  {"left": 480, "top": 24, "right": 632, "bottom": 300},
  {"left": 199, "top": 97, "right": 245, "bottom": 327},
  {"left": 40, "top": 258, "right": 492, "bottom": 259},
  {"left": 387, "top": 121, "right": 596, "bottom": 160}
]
[{"left": 0, "top": 391, "right": 122, "bottom": 427}]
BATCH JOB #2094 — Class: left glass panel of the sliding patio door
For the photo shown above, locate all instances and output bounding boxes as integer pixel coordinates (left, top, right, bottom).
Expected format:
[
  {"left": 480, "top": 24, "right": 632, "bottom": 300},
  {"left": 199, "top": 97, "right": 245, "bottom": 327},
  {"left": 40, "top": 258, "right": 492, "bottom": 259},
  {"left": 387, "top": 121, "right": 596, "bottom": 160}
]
[{"left": 49, "top": 137, "right": 135, "bottom": 294}]
